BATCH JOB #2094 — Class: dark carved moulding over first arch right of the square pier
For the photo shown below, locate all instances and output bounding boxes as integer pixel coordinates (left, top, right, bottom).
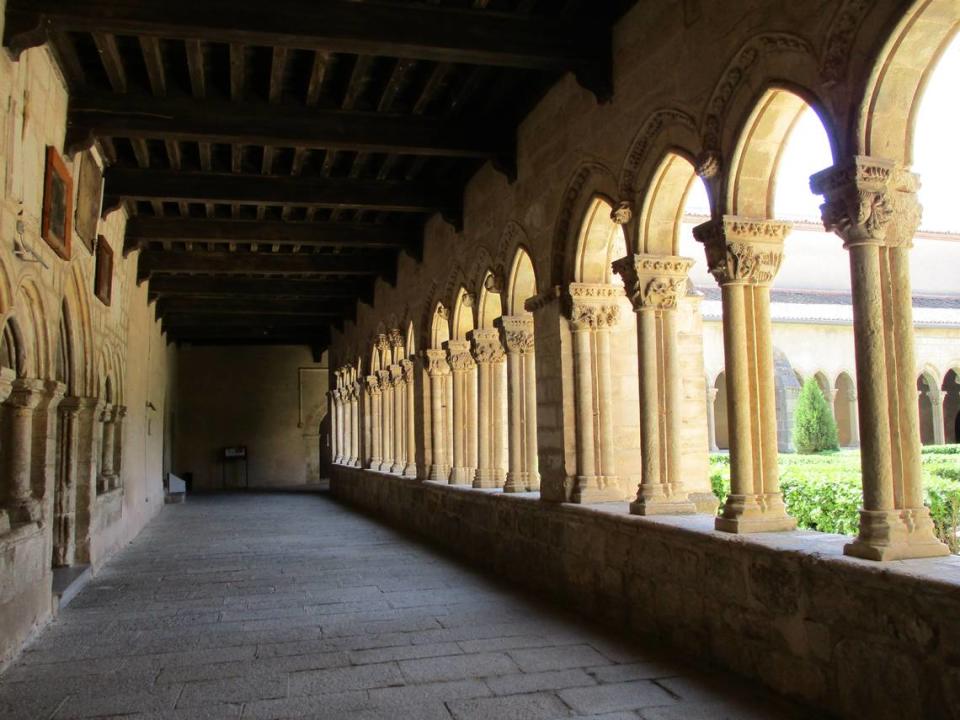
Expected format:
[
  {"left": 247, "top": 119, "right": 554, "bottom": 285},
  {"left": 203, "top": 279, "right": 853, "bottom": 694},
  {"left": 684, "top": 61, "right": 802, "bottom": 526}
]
[{"left": 551, "top": 162, "right": 629, "bottom": 285}]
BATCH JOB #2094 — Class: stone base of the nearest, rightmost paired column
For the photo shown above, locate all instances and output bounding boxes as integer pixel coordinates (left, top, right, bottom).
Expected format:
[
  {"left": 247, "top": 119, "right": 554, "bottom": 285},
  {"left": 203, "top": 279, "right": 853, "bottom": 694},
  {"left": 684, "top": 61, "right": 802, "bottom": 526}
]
[{"left": 843, "top": 507, "right": 950, "bottom": 561}]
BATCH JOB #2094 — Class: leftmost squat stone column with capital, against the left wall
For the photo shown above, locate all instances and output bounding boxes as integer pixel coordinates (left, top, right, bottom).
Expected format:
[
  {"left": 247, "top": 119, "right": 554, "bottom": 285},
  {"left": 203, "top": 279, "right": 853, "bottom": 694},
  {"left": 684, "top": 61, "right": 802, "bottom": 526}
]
[{"left": 4, "top": 378, "right": 45, "bottom": 524}]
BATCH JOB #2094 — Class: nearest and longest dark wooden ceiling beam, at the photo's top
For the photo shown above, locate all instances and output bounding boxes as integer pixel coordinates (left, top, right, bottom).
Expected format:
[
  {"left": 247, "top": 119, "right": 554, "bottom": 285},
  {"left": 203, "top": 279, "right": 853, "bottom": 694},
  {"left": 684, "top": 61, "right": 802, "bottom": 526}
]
[{"left": 4, "top": 0, "right": 609, "bottom": 71}]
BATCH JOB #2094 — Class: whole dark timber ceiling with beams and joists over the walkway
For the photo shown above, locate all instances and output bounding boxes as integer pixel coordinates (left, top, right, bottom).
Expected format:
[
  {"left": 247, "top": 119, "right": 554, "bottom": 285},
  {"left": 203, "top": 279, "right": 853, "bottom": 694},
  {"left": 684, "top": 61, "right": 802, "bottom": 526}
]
[{"left": 4, "top": 0, "right": 632, "bottom": 350}]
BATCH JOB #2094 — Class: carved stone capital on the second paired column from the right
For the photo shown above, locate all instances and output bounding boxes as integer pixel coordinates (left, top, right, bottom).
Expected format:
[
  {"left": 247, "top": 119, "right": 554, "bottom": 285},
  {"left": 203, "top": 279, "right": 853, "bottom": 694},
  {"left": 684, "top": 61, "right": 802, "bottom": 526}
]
[{"left": 693, "top": 215, "right": 792, "bottom": 285}]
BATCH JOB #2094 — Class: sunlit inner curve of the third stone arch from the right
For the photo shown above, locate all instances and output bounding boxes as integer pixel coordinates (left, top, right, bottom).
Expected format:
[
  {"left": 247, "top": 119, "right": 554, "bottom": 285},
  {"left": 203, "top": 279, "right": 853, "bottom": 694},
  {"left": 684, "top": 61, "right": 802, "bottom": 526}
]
[{"left": 635, "top": 150, "right": 697, "bottom": 255}]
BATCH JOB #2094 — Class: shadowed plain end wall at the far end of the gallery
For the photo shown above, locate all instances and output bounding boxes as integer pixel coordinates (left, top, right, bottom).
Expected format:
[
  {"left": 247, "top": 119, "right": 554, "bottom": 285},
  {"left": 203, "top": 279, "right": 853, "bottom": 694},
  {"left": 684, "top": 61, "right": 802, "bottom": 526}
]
[{"left": 174, "top": 345, "right": 328, "bottom": 490}]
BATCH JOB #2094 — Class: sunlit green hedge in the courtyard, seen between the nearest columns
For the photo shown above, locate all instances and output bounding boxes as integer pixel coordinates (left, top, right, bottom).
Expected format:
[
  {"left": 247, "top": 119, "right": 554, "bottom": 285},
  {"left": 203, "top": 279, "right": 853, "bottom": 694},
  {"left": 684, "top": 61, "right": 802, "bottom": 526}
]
[{"left": 710, "top": 446, "right": 960, "bottom": 553}]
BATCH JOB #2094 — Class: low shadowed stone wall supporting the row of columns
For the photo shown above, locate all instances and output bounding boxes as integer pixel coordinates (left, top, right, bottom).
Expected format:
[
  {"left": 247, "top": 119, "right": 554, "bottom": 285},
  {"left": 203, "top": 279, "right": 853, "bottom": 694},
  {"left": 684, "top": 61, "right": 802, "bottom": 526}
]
[{"left": 331, "top": 466, "right": 960, "bottom": 720}]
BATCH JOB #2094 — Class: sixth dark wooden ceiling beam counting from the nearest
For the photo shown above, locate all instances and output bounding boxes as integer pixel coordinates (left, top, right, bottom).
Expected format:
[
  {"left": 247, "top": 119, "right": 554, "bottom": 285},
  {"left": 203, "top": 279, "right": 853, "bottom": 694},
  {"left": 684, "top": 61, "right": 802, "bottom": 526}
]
[{"left": 149, "top": 275, "right": 364, "bottom": 300}]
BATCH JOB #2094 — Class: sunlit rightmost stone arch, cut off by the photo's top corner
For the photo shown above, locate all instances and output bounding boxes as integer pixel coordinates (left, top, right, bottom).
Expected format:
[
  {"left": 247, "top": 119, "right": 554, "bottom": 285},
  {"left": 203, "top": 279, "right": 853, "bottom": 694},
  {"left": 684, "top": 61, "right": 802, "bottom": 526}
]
[{"left": 853, "top": 0, "right": 960, "bottom": 167}]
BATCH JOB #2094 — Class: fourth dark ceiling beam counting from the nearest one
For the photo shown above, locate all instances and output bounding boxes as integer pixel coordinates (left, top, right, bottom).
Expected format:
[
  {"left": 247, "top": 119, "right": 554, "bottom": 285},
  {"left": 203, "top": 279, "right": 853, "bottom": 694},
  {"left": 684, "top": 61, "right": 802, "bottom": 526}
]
[{"left": 124, "top": 217, "right": 421, "bottom": 254}]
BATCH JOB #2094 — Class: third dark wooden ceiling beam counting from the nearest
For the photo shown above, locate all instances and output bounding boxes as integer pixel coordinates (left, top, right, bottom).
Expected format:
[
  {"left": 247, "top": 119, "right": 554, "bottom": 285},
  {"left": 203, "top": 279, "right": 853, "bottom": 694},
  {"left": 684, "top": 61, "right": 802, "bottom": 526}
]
[{"left": 105, "top": 167, "right": 461, "bottom": 217}]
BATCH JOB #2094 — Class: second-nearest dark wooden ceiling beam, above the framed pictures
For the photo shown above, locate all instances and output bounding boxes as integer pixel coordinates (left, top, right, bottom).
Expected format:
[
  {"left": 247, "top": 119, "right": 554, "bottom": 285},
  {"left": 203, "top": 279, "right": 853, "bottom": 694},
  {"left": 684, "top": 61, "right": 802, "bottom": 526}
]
[{"left": 67, "top": 94, "right": 512, "bottom": 159}]
